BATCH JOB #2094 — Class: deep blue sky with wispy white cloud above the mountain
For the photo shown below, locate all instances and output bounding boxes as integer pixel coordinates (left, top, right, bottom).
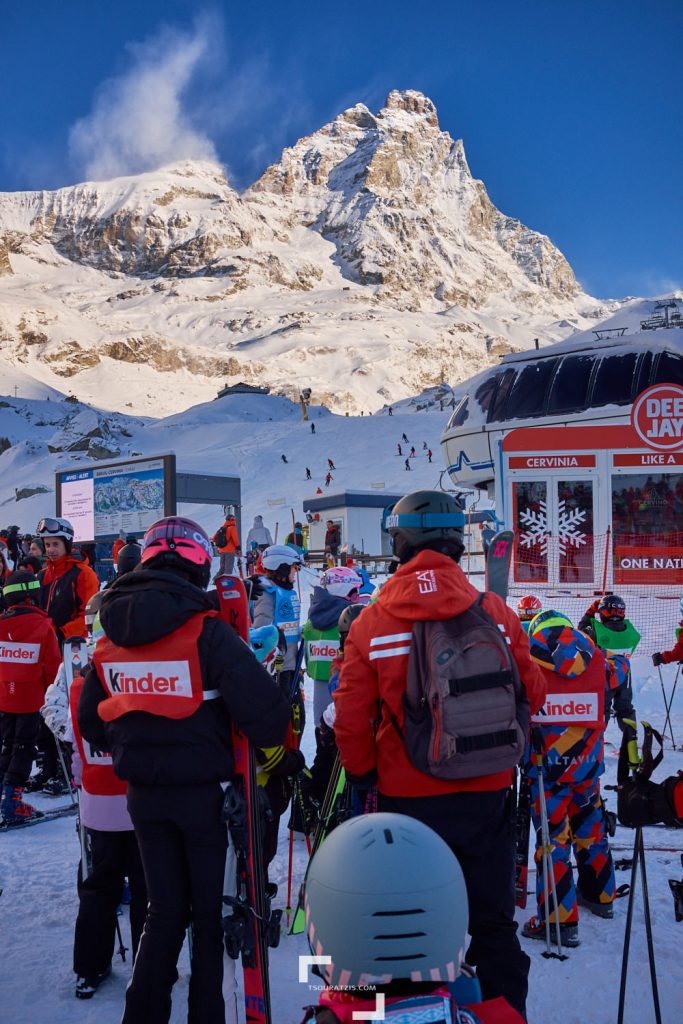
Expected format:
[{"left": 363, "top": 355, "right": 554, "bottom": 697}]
[{"left": 0, "top": 0, "right": 683, "bottom": 297}]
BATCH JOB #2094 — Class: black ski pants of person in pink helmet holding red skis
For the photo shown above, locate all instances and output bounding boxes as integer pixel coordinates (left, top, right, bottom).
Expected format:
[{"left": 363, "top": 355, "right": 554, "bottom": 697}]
[{"left": 121, "top": 782, "right": 227, "bottom": 1024}]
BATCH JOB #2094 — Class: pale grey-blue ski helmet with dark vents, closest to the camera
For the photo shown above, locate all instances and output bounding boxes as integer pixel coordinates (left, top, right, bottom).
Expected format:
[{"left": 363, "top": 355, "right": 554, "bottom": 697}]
[{"left": 304, "top": 813, "right": 468, "bottom": 987}]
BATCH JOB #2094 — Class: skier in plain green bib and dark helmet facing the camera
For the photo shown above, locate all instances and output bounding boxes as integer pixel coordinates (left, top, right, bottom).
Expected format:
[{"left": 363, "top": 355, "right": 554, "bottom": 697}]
[{"left": 579, "top": 594, "right": 640, "bottom": 731}]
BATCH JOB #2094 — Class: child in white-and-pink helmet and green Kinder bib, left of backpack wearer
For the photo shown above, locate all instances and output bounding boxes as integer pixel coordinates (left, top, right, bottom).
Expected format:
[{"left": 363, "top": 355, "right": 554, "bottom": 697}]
[{"left": 302, "top": 567, "right": 362, "bottom": 723}]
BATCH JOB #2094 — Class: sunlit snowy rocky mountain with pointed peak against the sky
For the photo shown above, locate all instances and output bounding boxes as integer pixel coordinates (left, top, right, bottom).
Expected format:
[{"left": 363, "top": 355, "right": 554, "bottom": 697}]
[{"left": 0, "top": 90, "right": 614, "bottom": 415}]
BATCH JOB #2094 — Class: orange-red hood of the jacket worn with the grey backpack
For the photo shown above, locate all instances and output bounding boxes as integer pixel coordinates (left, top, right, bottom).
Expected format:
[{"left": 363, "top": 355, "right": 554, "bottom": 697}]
[{"left": 377, "top": 551, "right": 479, "bottom": 622}]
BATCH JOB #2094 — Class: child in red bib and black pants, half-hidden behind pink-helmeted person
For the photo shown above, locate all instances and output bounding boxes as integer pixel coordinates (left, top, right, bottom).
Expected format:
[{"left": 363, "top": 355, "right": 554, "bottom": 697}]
[{"left": 41, "top": 593, "right": 147, "bottom": 999}]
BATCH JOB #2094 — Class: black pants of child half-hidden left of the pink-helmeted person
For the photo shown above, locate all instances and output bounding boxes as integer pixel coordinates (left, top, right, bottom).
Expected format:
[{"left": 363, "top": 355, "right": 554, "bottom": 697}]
[{"left": 74, "top": 828, "right": 147, "bottom": 978}]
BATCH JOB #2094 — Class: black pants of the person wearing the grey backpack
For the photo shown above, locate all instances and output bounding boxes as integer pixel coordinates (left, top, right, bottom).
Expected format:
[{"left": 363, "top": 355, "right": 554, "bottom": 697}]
[{"left": 378, "top": 790, "right": 530, "bottom": 1018}]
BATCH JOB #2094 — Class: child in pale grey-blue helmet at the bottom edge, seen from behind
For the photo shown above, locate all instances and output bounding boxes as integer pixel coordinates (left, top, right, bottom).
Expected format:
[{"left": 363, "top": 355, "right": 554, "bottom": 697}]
[{"left": 302, "top": 813, "right": 524, "bottom": 1024}]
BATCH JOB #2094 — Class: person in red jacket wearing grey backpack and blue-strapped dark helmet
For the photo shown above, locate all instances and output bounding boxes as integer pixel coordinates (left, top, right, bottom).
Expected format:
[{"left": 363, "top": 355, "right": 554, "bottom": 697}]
[{"left": 334, "top": 490, "right": 545, "bottom": 1015}]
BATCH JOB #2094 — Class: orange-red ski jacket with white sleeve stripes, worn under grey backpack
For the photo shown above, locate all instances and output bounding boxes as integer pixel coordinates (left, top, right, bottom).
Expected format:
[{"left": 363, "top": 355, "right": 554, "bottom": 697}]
[{"left": 334, "top": 551, "right": 546, "bottom": 797}]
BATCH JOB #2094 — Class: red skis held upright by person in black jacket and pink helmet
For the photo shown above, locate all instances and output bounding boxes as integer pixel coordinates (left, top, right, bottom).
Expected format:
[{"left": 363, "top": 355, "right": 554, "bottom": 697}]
[{"left": 216, "top": 575, "right": 282, "bottom": 1024}]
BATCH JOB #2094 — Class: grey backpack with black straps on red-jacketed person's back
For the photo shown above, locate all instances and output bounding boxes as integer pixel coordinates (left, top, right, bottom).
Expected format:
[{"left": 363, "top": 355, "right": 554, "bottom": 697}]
[{"left": 391, "top": 595, "right": 529, "bottom": 779}]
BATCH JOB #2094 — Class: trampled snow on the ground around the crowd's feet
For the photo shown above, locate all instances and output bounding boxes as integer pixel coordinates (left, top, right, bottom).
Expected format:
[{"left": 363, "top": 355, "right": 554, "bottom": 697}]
[{"left": 0, "top": 571, "right": 683, "bottom": 1024}]
